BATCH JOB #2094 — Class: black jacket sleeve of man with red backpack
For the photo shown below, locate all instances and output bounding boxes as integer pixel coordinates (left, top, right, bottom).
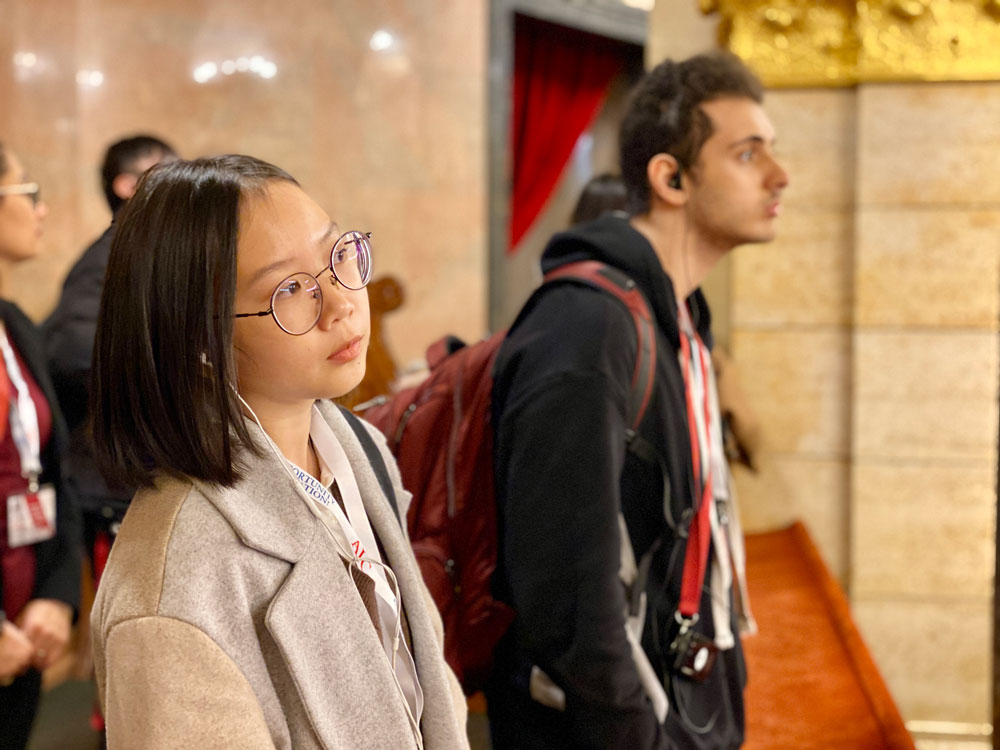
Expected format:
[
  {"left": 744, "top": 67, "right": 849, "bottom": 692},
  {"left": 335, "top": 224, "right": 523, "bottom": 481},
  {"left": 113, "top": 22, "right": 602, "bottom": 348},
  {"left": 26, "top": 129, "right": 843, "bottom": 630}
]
[{"left": 495, "top": 290, "right": 670, "bottom": 750}]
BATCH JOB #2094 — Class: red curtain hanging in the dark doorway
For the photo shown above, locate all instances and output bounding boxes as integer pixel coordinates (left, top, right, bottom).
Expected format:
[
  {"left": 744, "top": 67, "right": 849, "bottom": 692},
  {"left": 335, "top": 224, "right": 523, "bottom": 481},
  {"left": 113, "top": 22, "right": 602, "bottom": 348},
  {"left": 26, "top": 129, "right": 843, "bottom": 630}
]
[{"left": 507, "top": 15, "right": 625, "bottom": 252}]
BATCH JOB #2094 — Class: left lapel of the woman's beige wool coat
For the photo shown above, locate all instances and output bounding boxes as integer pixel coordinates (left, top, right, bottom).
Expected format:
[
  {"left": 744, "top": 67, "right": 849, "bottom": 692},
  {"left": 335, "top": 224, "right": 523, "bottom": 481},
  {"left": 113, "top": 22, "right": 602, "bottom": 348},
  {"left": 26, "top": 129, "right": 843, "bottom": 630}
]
[{"left": 199, "top": 424, "right": 410, "bottom": 748}]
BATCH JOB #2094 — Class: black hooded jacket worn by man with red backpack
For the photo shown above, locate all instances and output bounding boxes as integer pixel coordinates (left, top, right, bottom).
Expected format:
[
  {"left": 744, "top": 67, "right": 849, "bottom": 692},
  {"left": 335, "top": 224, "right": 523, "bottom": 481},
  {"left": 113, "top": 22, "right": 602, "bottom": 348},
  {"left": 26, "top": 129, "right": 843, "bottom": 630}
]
[{"left": 488, "top": 217, "right": 746, "bottom": 750}]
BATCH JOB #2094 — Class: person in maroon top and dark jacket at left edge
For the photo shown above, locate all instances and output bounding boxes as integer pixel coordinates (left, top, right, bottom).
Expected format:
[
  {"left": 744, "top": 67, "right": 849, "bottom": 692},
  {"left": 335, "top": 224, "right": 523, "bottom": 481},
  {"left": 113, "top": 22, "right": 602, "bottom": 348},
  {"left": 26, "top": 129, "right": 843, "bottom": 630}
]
[{"left": 0, "top": 144, "right": 82, "bottom": 749}]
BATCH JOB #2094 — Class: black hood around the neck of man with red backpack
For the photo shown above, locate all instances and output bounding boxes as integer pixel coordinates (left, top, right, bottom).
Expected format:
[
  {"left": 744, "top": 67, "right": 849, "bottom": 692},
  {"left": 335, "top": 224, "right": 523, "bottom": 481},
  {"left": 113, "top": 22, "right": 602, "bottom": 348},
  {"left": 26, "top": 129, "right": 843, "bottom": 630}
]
[{"left": 541, "top": 215, "right": 714, "bottom": 349}]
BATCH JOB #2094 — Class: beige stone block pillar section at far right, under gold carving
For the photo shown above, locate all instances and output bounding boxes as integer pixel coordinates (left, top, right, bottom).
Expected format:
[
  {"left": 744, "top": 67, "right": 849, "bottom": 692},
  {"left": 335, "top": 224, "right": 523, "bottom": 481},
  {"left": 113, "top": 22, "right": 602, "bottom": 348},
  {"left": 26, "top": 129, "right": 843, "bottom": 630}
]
[{"left": 850, "top": 83, "right": 1000, "bottom": 722}]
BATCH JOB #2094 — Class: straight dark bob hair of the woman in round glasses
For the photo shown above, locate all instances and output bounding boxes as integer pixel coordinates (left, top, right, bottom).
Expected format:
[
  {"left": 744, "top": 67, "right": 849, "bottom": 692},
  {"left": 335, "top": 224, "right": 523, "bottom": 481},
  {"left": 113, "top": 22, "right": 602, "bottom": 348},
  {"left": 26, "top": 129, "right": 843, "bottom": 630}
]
[{"left": 90, "top": 156, "right": 298, "bottom": 488}]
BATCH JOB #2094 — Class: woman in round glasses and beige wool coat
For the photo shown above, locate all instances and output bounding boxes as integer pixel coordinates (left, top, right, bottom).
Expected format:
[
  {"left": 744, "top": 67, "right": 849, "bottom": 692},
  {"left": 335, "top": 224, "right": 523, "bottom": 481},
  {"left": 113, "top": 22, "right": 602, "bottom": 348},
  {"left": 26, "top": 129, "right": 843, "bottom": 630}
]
[{"left": 91, "top": 156, "right": 468, "bottom": 750}]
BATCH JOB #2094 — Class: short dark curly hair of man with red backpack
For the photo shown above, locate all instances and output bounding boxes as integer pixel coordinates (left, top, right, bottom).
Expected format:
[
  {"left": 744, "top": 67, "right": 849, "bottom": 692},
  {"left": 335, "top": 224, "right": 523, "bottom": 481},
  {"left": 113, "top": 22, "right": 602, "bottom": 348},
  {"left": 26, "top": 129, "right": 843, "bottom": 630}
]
[{"left": 618, "top": 51, "right": 764, "bottom": 215}]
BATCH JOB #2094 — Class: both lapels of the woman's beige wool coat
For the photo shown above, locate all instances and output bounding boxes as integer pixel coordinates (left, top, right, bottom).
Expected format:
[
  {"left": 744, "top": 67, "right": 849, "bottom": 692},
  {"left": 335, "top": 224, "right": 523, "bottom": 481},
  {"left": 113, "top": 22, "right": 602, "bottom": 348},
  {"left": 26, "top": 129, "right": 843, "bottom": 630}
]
[{"left": 199, "top": 412, "right": 466, "bottom": 748}]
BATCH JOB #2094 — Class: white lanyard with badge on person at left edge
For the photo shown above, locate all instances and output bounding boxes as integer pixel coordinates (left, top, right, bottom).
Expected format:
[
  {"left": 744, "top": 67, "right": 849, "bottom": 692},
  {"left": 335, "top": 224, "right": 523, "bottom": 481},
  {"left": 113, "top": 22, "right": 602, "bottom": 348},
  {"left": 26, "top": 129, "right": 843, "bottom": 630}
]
[{"left": 0, "top": 324, "right": 56, "bottom": 548}]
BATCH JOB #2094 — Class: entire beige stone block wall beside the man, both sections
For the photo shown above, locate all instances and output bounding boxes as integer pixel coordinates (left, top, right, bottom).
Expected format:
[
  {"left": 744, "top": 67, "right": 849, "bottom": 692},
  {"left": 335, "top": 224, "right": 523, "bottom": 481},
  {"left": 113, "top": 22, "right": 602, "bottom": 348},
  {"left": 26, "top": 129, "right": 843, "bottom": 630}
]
[{"left": 647, "top": 0, "right": 1000, "bottom": 736}]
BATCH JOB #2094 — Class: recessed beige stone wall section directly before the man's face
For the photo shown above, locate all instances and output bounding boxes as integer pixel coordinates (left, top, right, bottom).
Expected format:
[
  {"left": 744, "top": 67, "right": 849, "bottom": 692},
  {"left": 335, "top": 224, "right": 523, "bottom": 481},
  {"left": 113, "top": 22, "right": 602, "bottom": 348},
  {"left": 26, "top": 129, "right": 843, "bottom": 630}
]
[{"left": 729, "top": 90, "right": 855, "bottom": 581}]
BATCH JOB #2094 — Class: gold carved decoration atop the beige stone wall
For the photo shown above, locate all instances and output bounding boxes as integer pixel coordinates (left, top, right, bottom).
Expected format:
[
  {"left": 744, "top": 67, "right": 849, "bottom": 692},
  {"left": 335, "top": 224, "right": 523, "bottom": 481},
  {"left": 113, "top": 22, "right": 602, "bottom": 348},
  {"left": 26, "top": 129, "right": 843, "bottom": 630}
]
[{"left": 699, "top": 0, "right": 1000, "bottom": 87}]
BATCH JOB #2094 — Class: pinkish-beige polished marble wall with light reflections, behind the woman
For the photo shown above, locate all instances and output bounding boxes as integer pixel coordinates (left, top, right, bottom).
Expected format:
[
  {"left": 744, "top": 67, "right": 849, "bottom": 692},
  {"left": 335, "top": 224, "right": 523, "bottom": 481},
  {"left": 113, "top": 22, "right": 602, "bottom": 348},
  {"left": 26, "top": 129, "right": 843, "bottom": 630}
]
[{"left": 0, "top": 0, "right": 488, "bottom": 362}]
